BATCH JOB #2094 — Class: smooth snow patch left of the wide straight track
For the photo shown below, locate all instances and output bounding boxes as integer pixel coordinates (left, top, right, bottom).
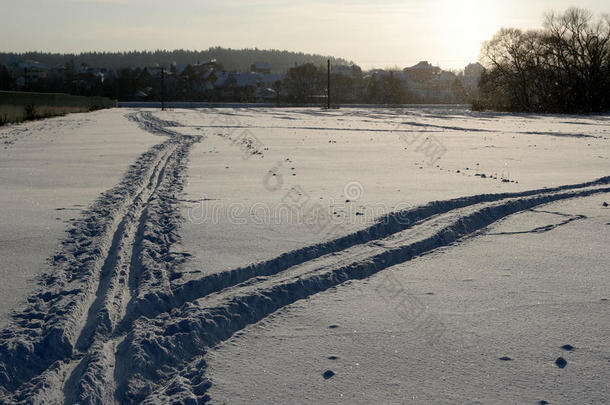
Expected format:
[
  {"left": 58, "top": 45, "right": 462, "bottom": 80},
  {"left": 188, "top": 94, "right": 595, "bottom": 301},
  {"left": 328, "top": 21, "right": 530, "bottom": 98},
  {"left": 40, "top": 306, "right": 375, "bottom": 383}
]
[{"left": 0, "top": 109, "right": 160, "bottom": 329}]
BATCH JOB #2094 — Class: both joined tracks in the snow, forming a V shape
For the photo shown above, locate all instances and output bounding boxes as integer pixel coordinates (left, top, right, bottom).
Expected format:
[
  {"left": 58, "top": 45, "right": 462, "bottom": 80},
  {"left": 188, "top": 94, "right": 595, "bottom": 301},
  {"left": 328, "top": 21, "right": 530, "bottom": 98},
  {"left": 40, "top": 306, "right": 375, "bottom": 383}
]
[{"left": 0, "top": 112, "right": 610, "bottom": 404}]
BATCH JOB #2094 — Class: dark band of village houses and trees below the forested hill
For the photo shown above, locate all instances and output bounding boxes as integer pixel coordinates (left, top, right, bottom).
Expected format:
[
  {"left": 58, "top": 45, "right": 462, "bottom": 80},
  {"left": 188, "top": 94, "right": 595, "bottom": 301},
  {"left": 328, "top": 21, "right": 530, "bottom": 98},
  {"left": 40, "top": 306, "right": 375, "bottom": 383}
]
[{"left": 0, "top": 61, "right": 473, "bottom": 104}]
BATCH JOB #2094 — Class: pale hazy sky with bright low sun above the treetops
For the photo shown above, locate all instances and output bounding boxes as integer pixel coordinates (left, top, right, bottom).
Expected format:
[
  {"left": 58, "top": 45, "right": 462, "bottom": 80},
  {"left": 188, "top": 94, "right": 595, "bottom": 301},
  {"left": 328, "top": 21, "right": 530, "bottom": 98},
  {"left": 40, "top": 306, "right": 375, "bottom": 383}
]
[{"left": 0, "top": 0, "right": 610, "bottom": 68}]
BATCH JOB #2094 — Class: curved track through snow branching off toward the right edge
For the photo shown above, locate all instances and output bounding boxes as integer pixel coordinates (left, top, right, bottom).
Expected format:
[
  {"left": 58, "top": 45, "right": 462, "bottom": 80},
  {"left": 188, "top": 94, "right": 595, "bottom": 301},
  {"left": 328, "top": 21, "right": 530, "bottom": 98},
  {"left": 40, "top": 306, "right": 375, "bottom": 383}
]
[{"left": 117, "top": 181, "right": 610, "bottom": 403}]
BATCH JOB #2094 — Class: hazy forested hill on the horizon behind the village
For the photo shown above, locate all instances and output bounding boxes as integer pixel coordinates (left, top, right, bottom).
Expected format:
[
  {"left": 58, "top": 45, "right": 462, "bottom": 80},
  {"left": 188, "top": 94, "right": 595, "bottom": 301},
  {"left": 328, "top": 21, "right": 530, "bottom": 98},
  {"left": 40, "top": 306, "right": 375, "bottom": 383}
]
[{"left": 0, "top": 47, "right": 350, "bottom": 73}]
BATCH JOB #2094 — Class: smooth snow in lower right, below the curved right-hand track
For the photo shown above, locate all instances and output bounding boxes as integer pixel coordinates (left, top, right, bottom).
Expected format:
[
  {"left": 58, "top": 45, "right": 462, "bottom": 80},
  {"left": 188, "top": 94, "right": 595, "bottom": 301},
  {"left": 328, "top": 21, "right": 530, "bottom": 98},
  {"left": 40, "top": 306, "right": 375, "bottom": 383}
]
[{"left": 205, "top": 194, "right": 610, "bottom": 404}]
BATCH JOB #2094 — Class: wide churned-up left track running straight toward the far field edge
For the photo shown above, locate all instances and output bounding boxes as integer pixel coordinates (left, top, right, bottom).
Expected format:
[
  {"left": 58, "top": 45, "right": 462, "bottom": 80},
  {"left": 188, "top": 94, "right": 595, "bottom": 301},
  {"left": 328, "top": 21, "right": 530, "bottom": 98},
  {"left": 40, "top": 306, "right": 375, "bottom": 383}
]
[{"left": 0, "top": 112, "right": 201, "bottom": 403}]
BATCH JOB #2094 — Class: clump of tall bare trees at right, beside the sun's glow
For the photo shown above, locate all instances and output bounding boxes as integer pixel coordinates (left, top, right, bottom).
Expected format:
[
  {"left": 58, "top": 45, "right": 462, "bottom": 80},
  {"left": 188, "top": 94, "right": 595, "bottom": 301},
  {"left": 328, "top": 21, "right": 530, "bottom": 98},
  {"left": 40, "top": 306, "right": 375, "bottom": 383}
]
[{"left": 473, "top": 8, "right": 610, "bottom": 113}]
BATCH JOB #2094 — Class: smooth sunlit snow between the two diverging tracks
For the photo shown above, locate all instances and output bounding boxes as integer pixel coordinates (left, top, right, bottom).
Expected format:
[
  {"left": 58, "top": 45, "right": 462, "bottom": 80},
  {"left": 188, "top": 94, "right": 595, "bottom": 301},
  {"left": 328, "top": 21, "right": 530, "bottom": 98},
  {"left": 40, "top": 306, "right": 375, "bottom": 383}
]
[{"left": 176, "top": 108, "right": 610, "bottom": 278}]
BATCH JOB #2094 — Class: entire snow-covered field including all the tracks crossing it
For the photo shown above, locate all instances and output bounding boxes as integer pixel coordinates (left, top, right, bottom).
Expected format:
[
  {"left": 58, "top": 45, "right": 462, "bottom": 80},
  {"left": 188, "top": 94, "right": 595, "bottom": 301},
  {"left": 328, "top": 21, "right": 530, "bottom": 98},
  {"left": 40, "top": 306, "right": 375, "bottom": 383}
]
[{"left": 0, "top": 108, "right": 610, "bottom": 403}]
